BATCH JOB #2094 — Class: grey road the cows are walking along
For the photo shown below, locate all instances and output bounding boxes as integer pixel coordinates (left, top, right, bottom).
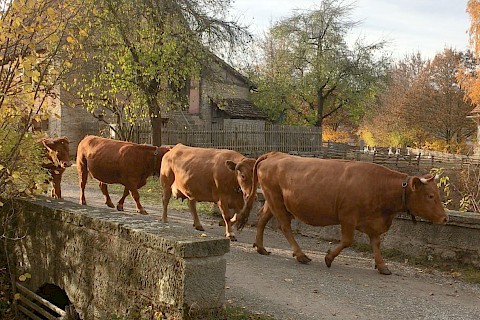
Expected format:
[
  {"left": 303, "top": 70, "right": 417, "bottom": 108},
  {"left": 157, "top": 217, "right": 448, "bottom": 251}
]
[{"left": 62, "top": 179, "right": 480, "bottom": 320}]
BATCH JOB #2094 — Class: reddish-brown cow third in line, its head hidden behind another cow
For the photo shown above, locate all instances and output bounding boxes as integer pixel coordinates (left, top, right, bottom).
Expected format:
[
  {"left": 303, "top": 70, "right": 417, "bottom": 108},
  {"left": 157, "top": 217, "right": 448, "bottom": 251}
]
[{"left": 77, "top": 136, "right": 170, "bottom": 214}]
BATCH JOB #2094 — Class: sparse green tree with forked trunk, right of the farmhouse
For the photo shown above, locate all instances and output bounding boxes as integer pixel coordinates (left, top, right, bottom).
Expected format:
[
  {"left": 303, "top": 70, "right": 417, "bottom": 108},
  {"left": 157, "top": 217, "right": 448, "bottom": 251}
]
[{"left": 248, "top": 0, "right": 389, "bottom": 140}]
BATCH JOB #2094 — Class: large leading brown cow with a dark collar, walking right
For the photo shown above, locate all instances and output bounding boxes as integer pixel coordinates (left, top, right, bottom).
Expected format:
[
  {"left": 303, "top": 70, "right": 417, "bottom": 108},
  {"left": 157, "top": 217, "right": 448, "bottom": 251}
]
[{"left": 237, "top": 152, "right": 448, "bottom": 274}]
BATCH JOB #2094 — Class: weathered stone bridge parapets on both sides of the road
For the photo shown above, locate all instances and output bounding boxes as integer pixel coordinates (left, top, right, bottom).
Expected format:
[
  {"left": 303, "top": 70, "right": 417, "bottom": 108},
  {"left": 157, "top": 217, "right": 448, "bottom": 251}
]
[{"left": 1, "top": 197, "right": 480, "bottom": 320}]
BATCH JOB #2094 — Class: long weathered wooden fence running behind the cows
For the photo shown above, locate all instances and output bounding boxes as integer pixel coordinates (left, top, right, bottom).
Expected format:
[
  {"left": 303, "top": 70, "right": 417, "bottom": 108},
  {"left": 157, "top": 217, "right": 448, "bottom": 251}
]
[{"left": 123, "top": 125, "right": 480, "bottom": 171}]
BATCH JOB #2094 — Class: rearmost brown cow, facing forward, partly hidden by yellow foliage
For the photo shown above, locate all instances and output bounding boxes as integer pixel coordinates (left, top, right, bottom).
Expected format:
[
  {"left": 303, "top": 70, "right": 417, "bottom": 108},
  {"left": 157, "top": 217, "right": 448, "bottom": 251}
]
[{"left": 39, "top": 137, "right": 72, "bottom": 199}]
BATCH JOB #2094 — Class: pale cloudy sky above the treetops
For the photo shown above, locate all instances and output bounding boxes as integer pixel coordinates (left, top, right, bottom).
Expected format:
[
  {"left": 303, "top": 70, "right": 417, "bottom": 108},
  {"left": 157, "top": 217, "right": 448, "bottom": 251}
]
[{"left": 232, "top": 0, "right": 470, "bottom": 59}]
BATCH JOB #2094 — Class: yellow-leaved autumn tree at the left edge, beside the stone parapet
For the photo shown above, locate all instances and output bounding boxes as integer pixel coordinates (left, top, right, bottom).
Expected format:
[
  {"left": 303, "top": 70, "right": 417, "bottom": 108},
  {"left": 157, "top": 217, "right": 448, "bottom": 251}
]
[{"left": 0, "top": 0, "right": 80, "bottom": 200}]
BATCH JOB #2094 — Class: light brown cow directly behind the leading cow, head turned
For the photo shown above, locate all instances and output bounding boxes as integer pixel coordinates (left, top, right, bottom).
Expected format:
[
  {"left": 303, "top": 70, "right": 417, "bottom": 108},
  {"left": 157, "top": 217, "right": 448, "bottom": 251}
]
[{"left": 160, "top": 144, "right": 255, "bottom": 240}]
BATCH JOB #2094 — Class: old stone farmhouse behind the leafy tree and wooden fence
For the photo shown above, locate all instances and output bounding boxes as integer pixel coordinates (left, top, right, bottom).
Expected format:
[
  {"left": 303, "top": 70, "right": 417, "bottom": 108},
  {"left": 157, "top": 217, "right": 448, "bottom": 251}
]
[{"left": 44, "top": 56, "right": 267, "bottom": 154}]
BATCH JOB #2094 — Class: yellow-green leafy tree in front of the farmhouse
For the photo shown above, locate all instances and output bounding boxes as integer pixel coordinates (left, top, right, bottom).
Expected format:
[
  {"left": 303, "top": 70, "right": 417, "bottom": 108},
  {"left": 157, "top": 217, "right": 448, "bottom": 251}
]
[{"left": 71, "top": 0, "right": 249, "bottom": 145}]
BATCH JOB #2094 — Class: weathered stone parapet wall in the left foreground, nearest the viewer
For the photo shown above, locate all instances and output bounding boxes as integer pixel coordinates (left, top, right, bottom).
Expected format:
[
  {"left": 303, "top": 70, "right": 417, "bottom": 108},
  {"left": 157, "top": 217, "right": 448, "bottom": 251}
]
[{"left": 3, "top": 198, "right": 230, "bottom": 320}]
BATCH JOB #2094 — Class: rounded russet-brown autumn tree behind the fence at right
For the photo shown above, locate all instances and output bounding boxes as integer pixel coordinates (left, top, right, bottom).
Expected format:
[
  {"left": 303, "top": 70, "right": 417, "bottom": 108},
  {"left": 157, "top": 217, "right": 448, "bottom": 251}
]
[{"left": 364, "top": 48, "right": 474, "bottom": 152}]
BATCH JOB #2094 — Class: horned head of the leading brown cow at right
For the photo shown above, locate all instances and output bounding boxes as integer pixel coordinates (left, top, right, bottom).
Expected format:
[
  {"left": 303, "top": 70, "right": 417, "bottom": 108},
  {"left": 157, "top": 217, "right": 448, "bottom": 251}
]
[{"left": 406, "top": 174, "right": 448, "bottom": 224}]
